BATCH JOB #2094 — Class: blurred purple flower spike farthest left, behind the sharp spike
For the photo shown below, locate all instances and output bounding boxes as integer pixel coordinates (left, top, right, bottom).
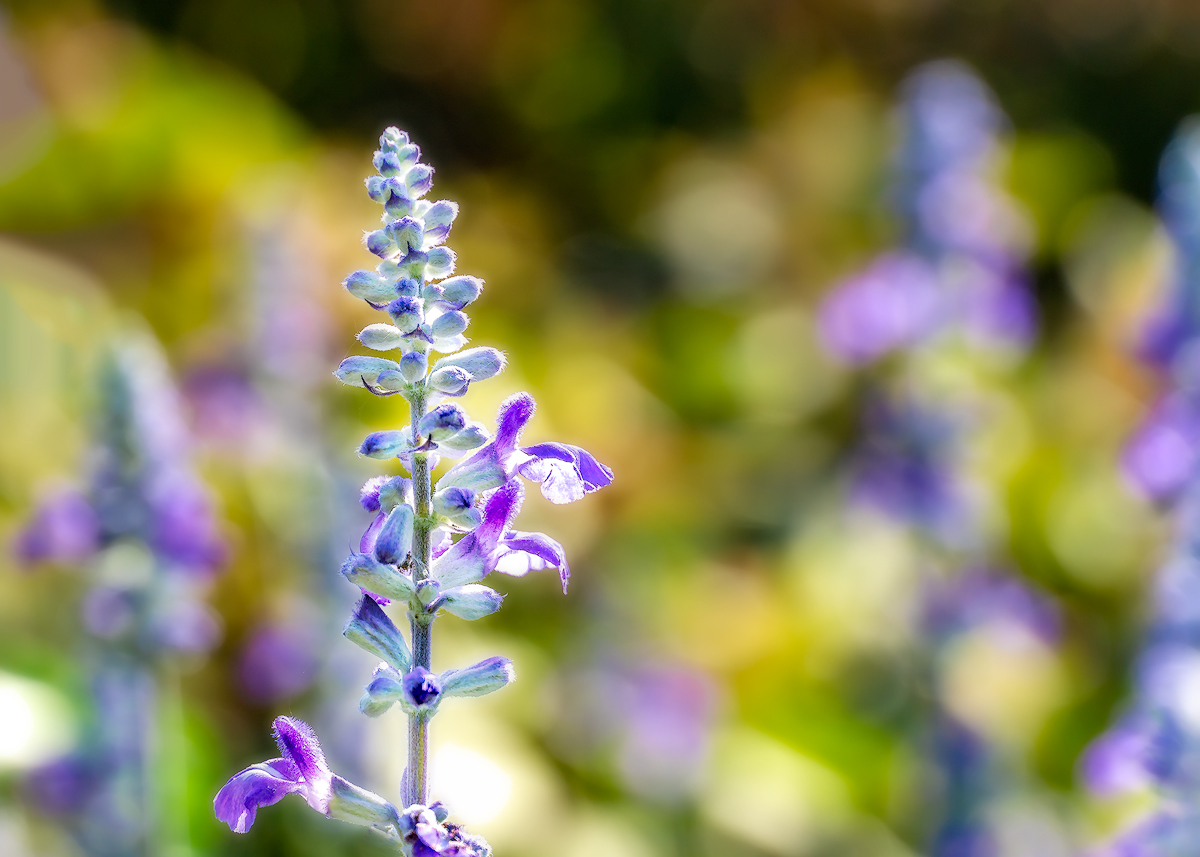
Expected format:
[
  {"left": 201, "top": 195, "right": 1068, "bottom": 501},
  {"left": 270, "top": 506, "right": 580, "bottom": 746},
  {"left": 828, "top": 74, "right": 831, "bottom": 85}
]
[{"left": 17, "top": 338, "right": 224, "bottom": 855}]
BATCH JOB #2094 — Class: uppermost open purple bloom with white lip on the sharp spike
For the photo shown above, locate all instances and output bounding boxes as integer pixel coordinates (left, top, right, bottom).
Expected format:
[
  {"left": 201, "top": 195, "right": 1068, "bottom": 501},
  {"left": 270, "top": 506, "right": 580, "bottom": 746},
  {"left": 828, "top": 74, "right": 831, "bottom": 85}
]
[{"left": 438, "top": 392, "right": 612, "bottom": 503}]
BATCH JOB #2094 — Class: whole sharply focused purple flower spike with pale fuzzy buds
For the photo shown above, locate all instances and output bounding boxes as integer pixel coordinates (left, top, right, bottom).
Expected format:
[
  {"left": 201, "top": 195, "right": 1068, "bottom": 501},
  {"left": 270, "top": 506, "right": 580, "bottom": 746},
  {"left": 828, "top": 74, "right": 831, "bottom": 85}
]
[{"left": 214, "top": 128, "right": 612, "bottom": 857}]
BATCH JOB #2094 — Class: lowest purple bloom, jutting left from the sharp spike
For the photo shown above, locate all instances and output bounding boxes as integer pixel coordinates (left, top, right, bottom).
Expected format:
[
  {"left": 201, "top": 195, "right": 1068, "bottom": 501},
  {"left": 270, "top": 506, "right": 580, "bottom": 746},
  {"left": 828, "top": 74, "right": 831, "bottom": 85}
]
[{"left": 212, "top": 717, "right": 332, "bottom": 833}]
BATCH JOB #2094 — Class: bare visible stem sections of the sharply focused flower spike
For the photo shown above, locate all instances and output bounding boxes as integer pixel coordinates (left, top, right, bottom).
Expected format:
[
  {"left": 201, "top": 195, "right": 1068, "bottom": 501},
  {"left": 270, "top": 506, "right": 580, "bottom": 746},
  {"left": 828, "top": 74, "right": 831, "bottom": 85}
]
[{"left": 404, "top": 388, "right": 433, "bottom": 807}]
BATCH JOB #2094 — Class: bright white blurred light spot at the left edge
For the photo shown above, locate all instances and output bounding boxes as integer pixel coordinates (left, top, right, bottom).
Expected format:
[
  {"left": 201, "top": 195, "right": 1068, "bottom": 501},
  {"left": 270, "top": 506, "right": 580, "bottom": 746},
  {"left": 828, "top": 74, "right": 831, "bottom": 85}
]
[{"left": 0, "top": 672, "right": 73, "bottom": 768}]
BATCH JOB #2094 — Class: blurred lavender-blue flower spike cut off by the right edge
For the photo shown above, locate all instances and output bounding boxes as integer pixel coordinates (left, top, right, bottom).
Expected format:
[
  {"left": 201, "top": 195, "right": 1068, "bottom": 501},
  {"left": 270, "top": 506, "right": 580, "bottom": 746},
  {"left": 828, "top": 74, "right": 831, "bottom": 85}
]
[{"left": 1081, "top": 118, "right": 1200, "bottom": 857}]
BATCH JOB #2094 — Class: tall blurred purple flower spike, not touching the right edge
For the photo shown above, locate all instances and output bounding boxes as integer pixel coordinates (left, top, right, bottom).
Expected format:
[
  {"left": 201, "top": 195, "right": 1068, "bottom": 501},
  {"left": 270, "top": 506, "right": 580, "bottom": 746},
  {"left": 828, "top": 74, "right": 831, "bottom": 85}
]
[{"left": 818, "top": 62, "right": 1052, "bottom": 857}]
